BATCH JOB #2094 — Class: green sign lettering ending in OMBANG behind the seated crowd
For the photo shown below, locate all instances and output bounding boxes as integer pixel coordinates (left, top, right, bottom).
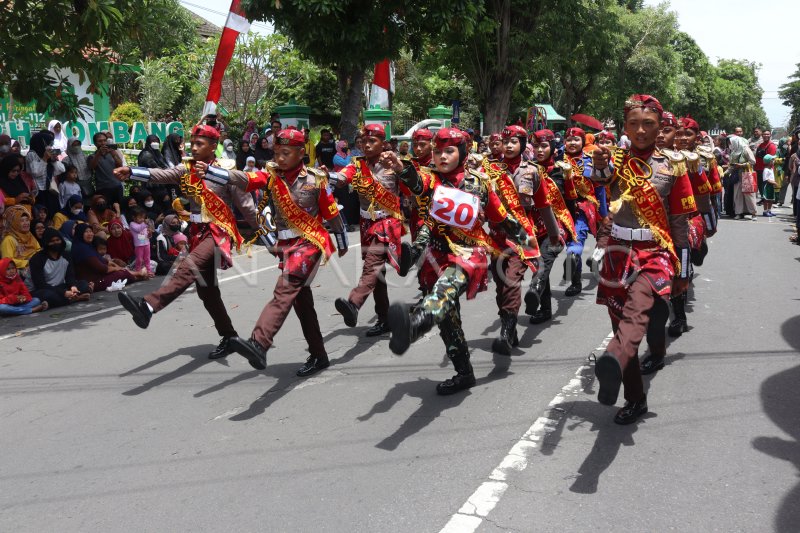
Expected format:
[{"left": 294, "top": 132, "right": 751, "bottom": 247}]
[{"left": 0, "top": 120, "right": 184, "bottom": 146}]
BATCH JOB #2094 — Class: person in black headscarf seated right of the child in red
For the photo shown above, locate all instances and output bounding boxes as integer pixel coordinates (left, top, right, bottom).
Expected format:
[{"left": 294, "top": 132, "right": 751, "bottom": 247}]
[{"left": 30, "top": 228, "right": 92, "bottom": 308}]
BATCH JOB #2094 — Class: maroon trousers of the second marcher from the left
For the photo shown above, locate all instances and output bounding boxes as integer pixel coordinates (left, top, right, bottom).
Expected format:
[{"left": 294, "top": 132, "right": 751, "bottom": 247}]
[{"left": 253, "top": 275, "right": 328, "bottom": 359}]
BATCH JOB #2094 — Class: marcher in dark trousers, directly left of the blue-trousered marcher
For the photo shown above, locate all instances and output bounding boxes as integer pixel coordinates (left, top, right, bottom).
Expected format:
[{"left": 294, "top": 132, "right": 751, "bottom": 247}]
[{"left": 525, "top": 130, "right": 575, "bottom": 324}]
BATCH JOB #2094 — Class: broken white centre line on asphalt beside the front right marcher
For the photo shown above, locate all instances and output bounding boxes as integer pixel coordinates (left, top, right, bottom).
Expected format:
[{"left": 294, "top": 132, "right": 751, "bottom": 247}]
[{"left": 440, "top": 333, "right": 614, "bottom": 533}]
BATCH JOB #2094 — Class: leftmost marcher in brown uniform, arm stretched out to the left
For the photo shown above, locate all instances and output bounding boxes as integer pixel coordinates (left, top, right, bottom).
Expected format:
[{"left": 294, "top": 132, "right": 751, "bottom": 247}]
[{"left": 114, "top": 116, "right": 265, "bottom": 359}]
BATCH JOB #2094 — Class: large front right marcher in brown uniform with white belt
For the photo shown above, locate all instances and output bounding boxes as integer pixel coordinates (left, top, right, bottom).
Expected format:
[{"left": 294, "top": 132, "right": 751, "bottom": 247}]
[{"left": 593, "top": 95, "right": 696, "bottom": 424}]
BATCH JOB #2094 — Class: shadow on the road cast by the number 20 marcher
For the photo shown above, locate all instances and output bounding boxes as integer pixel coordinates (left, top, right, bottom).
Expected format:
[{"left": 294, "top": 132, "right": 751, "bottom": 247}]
[{"left": 358, "top": 355, "right": 513, "bottom": 451}]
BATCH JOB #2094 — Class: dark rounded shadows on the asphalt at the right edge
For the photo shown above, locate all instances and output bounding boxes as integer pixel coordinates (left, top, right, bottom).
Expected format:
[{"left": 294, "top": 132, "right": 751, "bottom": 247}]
[{"left": 752, "top": 316, "right": 800, "bottom": 533}]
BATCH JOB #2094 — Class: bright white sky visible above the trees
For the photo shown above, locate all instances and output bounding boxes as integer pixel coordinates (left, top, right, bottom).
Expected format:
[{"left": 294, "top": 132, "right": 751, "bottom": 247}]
[{"left": 181, "top": 0, "right": 800, "bottom": 127}]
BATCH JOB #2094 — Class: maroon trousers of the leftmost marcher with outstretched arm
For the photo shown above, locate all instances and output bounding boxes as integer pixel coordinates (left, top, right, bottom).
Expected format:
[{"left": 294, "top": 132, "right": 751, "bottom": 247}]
[{"left": 144, "top": 233, "right": 237, "bottom": 337}]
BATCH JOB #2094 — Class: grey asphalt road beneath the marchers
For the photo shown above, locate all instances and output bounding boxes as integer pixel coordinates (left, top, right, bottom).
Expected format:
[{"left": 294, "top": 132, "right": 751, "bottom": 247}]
[{"left": 0, "top": 209, "right": 800, "bottom": 532}]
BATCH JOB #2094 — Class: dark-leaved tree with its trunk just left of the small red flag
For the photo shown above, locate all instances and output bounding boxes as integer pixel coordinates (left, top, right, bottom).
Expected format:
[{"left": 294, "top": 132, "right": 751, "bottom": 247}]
[{"left": 242, "top": 0, "right": 479, "bottom": 140}]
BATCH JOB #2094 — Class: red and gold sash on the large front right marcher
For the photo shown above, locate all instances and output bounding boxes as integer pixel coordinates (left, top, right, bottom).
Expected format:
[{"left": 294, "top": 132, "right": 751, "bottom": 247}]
[{"left": 612, "top": 150, "right": 681, "bottom": 272}]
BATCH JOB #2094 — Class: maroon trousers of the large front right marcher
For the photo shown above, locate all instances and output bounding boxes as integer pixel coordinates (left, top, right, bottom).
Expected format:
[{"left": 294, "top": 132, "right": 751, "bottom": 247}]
[{"left": 607, "top": 276, "right": 669, "bottom": 402}]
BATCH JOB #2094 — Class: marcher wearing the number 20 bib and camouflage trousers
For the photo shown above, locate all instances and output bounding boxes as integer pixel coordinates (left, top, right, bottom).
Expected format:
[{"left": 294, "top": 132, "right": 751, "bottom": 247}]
[{"left": 382, "top": 128, "right": 532, "bottom": 394}]
